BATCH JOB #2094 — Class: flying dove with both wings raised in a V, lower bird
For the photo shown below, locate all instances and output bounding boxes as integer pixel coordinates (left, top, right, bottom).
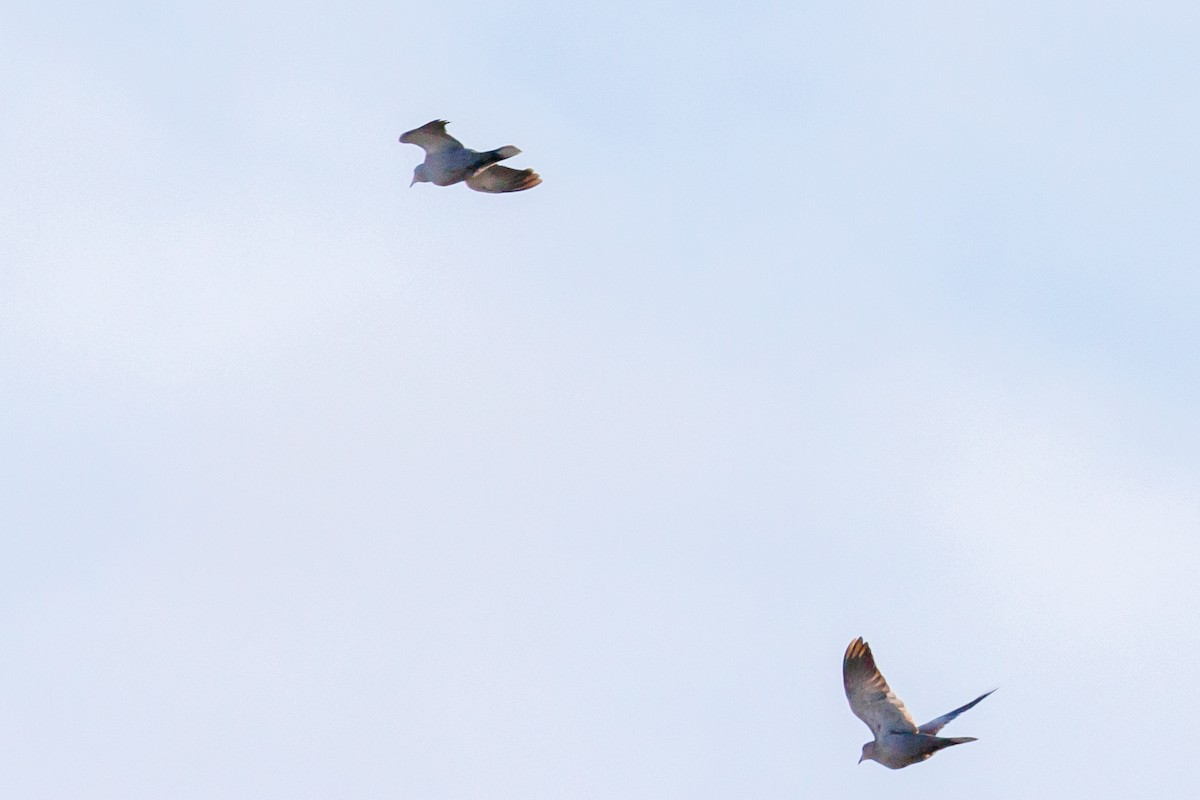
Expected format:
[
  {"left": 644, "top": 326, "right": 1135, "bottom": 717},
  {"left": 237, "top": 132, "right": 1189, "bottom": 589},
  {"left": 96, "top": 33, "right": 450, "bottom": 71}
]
[{"left": 841, "top": 637, "right": 996, "bottom": 770}]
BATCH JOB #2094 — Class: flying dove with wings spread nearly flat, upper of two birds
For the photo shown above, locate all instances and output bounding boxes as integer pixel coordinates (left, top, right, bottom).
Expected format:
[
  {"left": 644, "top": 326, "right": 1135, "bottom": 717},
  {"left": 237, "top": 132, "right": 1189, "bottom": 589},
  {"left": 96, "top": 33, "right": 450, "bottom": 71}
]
[{"left": 400, "top": 120, "right": 541, "bottom": 193}]
